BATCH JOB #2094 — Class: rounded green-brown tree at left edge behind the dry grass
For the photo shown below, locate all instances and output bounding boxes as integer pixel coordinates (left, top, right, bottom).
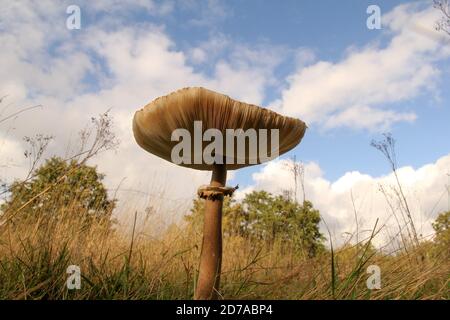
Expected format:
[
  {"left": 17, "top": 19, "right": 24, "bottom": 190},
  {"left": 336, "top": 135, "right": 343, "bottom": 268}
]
[{"left": 0, "top": 157, "right": 115, "bottom": 225}]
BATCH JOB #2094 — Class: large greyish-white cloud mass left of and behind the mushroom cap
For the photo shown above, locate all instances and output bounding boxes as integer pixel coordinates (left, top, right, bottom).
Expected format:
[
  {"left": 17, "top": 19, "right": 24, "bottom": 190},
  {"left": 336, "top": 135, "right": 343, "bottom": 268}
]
[{"left": 0, "top": 1, "right": 282, "bottom": 221}]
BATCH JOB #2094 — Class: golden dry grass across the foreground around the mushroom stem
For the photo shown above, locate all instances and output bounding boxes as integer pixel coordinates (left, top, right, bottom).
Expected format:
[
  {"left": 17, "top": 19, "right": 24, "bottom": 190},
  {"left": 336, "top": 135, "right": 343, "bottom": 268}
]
[{"left": 0, "top": 202, "right": 450, "bottom": 299}]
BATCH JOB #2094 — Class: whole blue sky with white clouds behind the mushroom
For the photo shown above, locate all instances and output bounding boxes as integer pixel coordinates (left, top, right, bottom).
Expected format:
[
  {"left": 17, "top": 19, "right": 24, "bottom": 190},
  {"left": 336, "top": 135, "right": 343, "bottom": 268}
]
[{"left": 0, "top": 0, "right": 450, "bottom": 245}]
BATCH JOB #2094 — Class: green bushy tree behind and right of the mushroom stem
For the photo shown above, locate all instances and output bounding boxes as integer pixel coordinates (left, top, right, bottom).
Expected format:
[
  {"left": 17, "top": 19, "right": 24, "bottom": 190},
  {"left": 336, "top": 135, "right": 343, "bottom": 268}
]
[{"left": 186, "top": 191, "right": 324, "bottom": 257}]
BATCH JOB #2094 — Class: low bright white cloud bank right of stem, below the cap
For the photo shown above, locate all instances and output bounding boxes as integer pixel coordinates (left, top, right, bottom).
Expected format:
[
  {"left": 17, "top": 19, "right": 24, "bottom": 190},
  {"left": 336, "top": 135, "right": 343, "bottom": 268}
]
[{"left": 236, "top": 154, "right": 450, "bottom": 245}]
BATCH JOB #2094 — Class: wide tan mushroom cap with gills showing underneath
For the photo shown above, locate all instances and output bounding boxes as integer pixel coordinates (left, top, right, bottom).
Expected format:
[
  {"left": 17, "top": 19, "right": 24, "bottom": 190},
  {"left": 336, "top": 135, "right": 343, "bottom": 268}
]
[{"left": 133, "top": 87, "right": 306, "bottom": 170}]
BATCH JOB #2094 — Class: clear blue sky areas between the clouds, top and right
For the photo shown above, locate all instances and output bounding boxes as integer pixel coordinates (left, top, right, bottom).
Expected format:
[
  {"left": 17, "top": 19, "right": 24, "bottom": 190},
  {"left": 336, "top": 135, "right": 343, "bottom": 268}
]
[{"left": 99, "top": 0, "right": 450, "bottom": 184}]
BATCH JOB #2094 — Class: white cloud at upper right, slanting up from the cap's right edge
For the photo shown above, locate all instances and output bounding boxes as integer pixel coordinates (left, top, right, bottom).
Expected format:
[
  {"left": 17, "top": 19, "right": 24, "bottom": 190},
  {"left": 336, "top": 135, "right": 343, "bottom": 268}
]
[{"left": 275, "top": 3, "right": 450, "bottom": 130}]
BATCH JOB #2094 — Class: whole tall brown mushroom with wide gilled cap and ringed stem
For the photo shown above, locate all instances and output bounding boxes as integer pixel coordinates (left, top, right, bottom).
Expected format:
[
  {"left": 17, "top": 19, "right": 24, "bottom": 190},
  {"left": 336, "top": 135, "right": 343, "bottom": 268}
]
[{"left": 133, "top": 87, "right": 306, "bottom": 300}]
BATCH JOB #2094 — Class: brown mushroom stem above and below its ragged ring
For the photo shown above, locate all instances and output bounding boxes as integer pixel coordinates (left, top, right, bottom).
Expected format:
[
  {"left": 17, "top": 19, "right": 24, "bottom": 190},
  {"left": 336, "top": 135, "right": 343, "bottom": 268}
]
[{"left": 194, "top": 164, "right": 227, "bottom": 300}]
